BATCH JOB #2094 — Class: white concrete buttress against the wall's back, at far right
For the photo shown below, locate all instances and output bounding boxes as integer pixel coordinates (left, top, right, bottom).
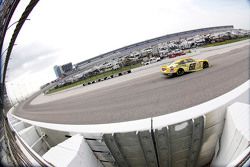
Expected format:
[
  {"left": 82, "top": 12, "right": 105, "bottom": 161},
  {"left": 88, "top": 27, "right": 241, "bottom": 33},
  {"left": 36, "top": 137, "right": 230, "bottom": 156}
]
[{"left": 212, "top": 103, "right": 250, "bottom": 166}]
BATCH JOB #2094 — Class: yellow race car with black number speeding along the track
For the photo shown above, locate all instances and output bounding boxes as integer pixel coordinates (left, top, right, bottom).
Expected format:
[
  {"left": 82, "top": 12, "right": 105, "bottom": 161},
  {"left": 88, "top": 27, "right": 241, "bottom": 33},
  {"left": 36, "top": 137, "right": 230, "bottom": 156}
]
[{"left": 161, "top": 57, "right": 209, "bottom": 76}]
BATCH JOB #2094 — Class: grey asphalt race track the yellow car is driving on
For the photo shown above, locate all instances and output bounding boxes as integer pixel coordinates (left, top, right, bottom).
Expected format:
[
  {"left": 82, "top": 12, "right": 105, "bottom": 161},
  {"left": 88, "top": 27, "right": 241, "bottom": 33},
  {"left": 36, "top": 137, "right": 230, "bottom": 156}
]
[{"left": 15, "top": 45, "right": 250, "bottom": 124}]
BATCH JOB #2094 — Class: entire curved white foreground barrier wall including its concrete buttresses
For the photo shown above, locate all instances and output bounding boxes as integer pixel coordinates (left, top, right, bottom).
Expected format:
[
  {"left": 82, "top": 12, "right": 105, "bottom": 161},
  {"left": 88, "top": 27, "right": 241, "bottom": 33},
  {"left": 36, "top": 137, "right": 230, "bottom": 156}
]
[{"left": 8, "top": 80, "right": 250, "bottom": 167}]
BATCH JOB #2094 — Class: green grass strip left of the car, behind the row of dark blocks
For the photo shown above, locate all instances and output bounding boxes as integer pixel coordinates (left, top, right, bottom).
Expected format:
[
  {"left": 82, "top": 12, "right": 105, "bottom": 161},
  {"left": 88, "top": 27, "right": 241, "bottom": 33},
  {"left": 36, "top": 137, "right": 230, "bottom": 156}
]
[{"left": 47, "top": 63, "right": 142, "bottom": 94}]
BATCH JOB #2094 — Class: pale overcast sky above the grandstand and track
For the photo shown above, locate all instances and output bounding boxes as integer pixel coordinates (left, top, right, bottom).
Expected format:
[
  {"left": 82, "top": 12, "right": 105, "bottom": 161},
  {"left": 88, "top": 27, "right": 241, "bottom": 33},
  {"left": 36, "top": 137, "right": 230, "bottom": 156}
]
[{"left": 4, "top": 0, "right": 250, "bottom": 101}]
